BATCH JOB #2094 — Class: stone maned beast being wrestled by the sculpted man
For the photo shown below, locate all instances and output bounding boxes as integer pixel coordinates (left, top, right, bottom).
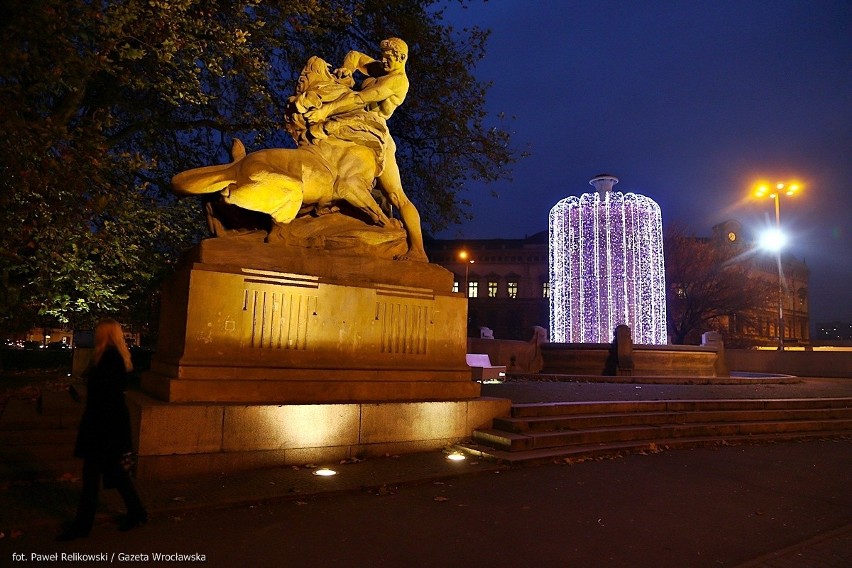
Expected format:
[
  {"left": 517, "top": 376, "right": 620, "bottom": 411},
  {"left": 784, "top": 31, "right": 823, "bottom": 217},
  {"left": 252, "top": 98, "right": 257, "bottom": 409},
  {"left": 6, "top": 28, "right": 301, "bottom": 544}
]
[{"left": 172, "top": 57, "right": 390, "bottom": 226}]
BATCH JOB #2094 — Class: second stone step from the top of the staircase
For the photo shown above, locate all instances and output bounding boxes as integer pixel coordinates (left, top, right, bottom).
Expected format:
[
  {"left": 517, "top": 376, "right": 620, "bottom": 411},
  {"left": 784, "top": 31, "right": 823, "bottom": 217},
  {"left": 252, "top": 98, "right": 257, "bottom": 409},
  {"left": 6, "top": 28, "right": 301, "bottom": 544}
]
[{"left": 493, "top": 407, "right": 852, "bottom": 433}]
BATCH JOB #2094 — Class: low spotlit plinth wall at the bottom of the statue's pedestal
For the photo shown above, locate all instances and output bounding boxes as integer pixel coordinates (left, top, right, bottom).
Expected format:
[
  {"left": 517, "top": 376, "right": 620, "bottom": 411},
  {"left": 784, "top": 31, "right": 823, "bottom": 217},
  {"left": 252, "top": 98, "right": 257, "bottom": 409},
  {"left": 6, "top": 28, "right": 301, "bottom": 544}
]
[{"left": 128, "top": 392, "right": 511, "bottom": 479}]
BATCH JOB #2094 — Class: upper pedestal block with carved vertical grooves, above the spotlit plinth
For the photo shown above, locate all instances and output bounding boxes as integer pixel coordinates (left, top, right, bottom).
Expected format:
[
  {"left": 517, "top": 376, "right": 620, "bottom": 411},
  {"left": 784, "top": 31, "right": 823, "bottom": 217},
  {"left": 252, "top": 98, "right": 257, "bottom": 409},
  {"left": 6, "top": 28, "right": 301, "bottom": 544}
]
[{"left": 142, "top": 239, "right": 480, "bottom": 403}]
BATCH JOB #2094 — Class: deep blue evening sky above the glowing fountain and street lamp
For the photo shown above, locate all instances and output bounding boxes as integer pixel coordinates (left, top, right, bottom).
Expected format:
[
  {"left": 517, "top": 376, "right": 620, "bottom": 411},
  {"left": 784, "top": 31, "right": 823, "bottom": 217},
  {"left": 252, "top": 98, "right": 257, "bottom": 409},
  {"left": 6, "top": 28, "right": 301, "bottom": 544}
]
[{"left": 436, "top": 0, "right": 852, "bottom": 323}]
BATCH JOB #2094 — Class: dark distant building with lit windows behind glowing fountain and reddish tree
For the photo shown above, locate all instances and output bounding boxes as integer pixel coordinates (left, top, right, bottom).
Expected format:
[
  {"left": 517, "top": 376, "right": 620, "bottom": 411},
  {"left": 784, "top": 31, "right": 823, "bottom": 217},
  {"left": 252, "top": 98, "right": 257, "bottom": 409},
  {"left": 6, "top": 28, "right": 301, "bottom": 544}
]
[{"left": 426, "top": 220, "right": 810, "bottom": 346}]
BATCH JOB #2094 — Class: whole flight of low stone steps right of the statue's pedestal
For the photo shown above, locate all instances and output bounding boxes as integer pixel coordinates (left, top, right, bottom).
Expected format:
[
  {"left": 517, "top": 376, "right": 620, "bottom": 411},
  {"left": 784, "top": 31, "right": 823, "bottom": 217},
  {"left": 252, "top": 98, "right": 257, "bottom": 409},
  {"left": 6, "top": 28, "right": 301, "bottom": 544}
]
[{"left": 461, "top": 398, "right": 852, "bottom": 464}]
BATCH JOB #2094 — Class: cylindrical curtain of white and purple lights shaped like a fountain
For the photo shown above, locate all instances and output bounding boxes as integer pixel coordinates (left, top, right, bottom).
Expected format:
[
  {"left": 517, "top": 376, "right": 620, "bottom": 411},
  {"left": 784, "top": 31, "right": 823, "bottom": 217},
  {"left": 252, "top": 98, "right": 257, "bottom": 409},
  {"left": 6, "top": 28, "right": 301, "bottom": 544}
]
[{"left": 550, "top": 175, "right": 667, "bottom": 345}]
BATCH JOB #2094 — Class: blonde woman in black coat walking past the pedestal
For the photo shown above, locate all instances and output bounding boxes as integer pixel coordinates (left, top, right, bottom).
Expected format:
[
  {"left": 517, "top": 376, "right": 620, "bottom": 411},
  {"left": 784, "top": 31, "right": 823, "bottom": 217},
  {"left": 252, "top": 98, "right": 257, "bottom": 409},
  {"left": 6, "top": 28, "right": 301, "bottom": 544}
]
[{"left": 58, "top": 319, "right": 148, "bottom": 540}]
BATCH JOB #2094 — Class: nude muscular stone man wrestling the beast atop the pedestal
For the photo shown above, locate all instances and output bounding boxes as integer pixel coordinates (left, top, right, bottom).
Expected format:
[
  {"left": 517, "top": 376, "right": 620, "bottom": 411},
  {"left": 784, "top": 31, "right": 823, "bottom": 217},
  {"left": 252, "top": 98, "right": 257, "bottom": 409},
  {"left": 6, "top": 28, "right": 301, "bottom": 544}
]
[{"left": 304, "top": 38, "right": 427, "bottom": 262}]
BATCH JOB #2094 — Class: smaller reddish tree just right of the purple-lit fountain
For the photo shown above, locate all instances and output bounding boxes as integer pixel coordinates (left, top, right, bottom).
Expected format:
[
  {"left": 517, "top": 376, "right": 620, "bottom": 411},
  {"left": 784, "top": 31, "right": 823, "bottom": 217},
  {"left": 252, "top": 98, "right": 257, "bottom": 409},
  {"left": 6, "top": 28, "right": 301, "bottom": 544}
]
[{"left": 664, "top": 225, "right": 777, "bottom": 344}]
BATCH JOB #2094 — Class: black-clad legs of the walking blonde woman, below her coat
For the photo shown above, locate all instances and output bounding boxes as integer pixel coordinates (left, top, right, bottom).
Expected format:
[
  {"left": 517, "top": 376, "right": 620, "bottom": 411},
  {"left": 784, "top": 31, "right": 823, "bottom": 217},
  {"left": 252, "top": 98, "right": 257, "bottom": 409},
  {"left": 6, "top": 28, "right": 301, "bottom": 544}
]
[{"left": 74, "top": 457, "right": 147, "bottom": 534}]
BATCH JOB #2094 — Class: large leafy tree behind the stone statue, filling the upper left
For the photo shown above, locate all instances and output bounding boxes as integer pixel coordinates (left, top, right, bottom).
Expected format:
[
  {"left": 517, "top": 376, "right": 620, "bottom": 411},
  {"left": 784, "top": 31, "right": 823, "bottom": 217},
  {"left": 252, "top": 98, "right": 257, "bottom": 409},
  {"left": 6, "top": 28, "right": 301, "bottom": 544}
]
[{"left": 0, "top": 0, "right": 517, "bottom": 326}]
